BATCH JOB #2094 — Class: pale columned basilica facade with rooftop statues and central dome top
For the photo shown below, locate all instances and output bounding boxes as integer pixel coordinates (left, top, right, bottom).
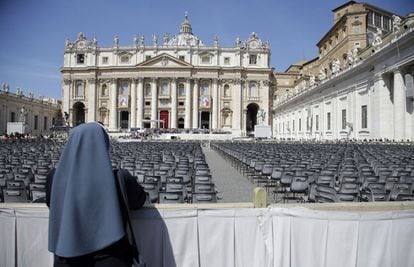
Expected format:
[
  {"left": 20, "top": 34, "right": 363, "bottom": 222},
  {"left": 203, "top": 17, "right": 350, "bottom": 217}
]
[{"left": 61, "top": 15, "right": 274, "bottom": 134}]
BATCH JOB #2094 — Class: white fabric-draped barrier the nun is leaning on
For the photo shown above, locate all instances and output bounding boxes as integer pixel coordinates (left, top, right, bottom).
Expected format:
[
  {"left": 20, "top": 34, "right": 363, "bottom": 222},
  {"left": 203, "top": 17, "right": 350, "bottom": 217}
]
[{"left": 0, "top": 204, "right": 414, "bottom": 267}]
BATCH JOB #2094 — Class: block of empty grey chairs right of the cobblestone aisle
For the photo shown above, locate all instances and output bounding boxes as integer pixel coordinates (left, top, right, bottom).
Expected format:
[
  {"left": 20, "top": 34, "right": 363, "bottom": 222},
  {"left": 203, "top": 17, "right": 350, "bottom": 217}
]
[{"left": 212, "top": 142, "right": 414, "bottom": 202}]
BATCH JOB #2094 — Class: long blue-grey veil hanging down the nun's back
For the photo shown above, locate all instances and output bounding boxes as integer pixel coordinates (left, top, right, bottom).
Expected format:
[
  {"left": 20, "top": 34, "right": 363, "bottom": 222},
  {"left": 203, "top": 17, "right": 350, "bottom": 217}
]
[{"left": 49, "top": 123, "right": 125, "bottom": 257}]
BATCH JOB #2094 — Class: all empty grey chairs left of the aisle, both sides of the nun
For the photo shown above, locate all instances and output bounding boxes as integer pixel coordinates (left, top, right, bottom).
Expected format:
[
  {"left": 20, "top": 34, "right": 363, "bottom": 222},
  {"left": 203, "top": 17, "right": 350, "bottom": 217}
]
[{"left": 0, "top": 140, "right": 217, "bottom": 203}]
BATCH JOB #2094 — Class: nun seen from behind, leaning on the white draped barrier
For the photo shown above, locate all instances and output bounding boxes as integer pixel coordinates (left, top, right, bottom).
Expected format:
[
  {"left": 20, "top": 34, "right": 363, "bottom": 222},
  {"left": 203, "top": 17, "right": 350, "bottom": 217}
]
[{"left": 46, "top": 122, "right": 146, "bottom": 267}]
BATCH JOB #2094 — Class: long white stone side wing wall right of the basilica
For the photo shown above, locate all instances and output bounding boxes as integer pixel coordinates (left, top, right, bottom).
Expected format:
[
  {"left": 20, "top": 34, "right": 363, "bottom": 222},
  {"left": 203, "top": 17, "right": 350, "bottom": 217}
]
[{"left": 274, "top": 29, "right": 414, "bottom": 141}]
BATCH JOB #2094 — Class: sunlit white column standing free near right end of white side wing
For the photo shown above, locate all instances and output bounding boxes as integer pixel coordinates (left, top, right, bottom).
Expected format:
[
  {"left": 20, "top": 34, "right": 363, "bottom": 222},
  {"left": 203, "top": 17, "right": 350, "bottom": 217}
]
[{"left": 393, "top": 69, "right": 406, "bottom": 141}]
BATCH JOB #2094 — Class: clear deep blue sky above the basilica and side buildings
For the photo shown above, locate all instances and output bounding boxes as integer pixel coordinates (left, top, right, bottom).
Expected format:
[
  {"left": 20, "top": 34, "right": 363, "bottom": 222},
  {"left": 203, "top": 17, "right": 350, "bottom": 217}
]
[{"left": 0, "top": 0, "right": 414, "bottom": 99}]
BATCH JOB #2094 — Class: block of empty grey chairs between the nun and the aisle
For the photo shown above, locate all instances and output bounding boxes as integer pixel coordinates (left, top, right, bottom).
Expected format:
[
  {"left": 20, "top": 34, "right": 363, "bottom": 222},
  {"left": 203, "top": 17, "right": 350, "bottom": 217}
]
[{"left": 111, "top": 142, "right": 217, "bottom": 203}]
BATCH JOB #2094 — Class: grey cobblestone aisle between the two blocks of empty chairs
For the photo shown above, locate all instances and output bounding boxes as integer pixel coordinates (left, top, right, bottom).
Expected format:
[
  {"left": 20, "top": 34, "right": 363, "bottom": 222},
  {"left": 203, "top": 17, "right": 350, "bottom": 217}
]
[{"left": 203, "top": 147, "right": 255, "bottom": 203}]
